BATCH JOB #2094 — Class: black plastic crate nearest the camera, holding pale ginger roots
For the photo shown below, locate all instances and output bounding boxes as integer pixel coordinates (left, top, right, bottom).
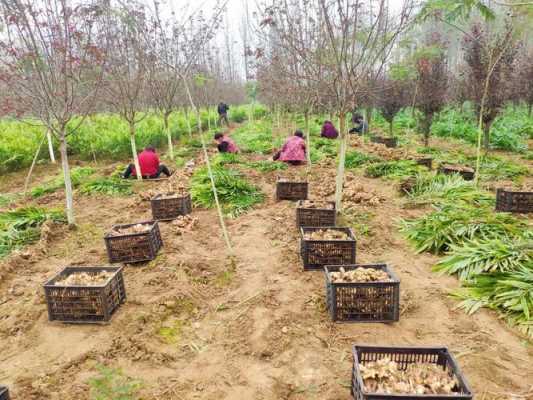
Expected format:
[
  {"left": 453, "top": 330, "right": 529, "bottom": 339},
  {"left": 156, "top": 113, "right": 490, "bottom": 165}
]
[{"left": 351, "top": 345, "right": 473, "bottom": 400}]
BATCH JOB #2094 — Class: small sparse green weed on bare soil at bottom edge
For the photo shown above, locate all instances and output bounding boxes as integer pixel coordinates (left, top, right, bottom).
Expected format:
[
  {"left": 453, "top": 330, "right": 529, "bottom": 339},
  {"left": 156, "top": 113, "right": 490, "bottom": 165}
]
[{"left": 89, "top": 365, "right": 142, "bottom": 400}]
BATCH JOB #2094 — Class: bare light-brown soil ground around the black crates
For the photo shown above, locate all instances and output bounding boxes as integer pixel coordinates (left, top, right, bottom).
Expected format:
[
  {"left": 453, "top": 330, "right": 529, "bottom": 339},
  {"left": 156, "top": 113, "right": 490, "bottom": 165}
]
[{"left": 0, "top": 129, "right": 533, "bottom": 400}]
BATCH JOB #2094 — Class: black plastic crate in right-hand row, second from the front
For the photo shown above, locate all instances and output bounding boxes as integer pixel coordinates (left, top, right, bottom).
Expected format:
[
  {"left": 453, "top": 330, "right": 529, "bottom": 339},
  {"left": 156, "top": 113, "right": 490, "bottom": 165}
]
[{"left": 324, "top": 264, "right": 400, "bottom": 322}]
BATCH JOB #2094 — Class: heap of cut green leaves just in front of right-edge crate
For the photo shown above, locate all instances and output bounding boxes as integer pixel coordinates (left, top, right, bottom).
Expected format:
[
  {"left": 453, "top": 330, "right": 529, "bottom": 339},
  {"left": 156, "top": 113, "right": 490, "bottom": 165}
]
[{"left": 400, "top": 204, "right": 527, "bottom": 253}]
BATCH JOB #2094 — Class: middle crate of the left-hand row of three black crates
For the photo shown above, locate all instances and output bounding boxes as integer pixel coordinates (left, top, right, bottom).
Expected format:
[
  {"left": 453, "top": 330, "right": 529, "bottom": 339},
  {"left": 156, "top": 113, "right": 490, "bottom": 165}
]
[{"left": 104, "top": 221, "right": 163, "bottom": 263}]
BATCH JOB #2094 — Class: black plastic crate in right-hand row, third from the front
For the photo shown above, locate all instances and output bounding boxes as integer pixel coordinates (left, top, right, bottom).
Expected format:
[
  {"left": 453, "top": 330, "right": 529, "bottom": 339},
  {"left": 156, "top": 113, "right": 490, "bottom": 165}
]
[{"left": 300, "top": 226, "right": 356, "bottom": 271}]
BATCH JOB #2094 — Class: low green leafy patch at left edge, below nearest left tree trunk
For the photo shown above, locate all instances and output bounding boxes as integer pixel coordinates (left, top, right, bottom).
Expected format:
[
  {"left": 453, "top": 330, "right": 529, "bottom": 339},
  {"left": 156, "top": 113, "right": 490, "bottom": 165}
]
[{"left": 0, "top": 207, "right": 65, "bottom": 258}]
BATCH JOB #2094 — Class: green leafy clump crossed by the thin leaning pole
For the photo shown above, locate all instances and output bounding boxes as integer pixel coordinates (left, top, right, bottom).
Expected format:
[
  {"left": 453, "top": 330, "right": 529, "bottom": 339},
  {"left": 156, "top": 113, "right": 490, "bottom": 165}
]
[{"left": 191, "top": 165, "right": 264, "bottom": 217}]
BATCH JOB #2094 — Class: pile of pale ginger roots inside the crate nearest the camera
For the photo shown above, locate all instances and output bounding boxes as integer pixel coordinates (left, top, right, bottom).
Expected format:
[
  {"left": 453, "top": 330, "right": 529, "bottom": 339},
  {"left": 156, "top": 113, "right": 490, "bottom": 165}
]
[{"left": 360, "top": 358, "right": 458, "bottom": 395}]
